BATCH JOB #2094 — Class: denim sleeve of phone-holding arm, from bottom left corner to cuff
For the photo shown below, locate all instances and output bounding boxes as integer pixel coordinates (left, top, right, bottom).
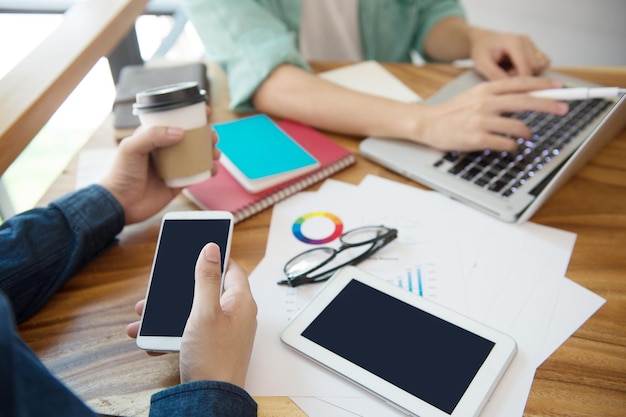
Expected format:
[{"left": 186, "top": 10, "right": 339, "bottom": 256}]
[{"left": 0, "top": 291, "right": 257, "bottom": 417}]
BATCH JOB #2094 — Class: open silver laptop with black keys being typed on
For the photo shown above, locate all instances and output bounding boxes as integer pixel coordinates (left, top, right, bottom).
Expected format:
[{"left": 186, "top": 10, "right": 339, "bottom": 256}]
[{"left": 359, "top": 70, "right": 626, "bottom": 223}]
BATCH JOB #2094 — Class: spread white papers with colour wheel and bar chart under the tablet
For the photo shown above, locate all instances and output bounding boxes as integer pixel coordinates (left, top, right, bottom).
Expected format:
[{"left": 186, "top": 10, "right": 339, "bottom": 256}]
[{"left": 246, "top": 176, "right": 604, "bottom": 417}]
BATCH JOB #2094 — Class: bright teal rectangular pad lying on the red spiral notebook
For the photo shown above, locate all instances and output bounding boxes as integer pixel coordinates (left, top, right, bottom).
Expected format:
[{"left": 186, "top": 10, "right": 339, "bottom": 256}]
[{"left": 213, "top": 114, "right": 319, "bottom": 181}]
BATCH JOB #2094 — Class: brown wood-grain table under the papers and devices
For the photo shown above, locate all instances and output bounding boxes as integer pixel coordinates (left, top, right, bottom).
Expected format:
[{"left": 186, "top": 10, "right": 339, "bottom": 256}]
[{"left": 19, "top": 64, "right": 626, "bottom": 417}]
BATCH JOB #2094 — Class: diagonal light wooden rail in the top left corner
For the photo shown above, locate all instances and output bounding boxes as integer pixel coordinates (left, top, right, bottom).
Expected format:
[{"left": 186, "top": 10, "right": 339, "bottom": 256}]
[{"left": 0, "top": 0, "right": 148, "bottom": 175}]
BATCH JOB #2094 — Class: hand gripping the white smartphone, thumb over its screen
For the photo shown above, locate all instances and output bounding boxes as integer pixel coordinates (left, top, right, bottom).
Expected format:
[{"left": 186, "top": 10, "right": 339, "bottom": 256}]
[{"left": 126, "top": 243, "right": 257, "bottom": 387}]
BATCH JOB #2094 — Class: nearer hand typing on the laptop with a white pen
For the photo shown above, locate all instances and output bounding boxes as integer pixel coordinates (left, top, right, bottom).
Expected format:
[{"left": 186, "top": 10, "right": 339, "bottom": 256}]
[{"left": 413, "top": 77, "right": 568, "bottom": 151}]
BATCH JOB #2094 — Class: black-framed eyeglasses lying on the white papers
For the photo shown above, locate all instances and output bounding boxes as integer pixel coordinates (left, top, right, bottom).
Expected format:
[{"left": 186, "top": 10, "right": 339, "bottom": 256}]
[{"left": 278, "top": 226, "right": 398, "bottom": 287}]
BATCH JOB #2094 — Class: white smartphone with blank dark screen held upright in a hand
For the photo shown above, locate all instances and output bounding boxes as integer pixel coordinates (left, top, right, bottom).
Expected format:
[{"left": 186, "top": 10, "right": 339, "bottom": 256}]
[{"left": 137, "top": 211, "right": 233, "bottom": 352}]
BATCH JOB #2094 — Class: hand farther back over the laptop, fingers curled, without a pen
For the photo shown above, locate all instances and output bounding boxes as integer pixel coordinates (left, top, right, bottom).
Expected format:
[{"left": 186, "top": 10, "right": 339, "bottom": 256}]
[{"left": 470, "top": 28, "right": 550, "bottom": 80}]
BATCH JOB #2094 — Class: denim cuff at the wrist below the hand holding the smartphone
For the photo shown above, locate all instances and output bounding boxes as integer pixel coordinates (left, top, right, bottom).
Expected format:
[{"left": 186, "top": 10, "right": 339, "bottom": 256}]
[{"left": 150, "top": 381, "right": 257, "bottom": 417}]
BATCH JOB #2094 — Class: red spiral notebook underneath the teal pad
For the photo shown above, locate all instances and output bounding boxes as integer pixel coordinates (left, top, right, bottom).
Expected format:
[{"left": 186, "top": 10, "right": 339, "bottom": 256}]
[{"left": 183, "top": 120, "right": 356, "bottom": 223}]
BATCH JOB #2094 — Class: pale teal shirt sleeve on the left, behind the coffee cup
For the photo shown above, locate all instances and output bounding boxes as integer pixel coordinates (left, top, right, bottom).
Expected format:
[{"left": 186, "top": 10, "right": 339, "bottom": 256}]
[{"left": 183, "top": 0, "right": 310, "bottom": 112}]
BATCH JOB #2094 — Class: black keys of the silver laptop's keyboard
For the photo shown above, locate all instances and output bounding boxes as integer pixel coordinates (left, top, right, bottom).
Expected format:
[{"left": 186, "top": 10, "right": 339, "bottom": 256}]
[{"left": 434, "top": 99, "right": 612, "bottom": 197}]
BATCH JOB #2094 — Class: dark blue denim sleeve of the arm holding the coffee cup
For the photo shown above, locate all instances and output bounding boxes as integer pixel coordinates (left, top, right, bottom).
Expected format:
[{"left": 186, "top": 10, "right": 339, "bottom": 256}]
[{"left": 0, "top": 185, "right": 124, "bottom": 322}]
